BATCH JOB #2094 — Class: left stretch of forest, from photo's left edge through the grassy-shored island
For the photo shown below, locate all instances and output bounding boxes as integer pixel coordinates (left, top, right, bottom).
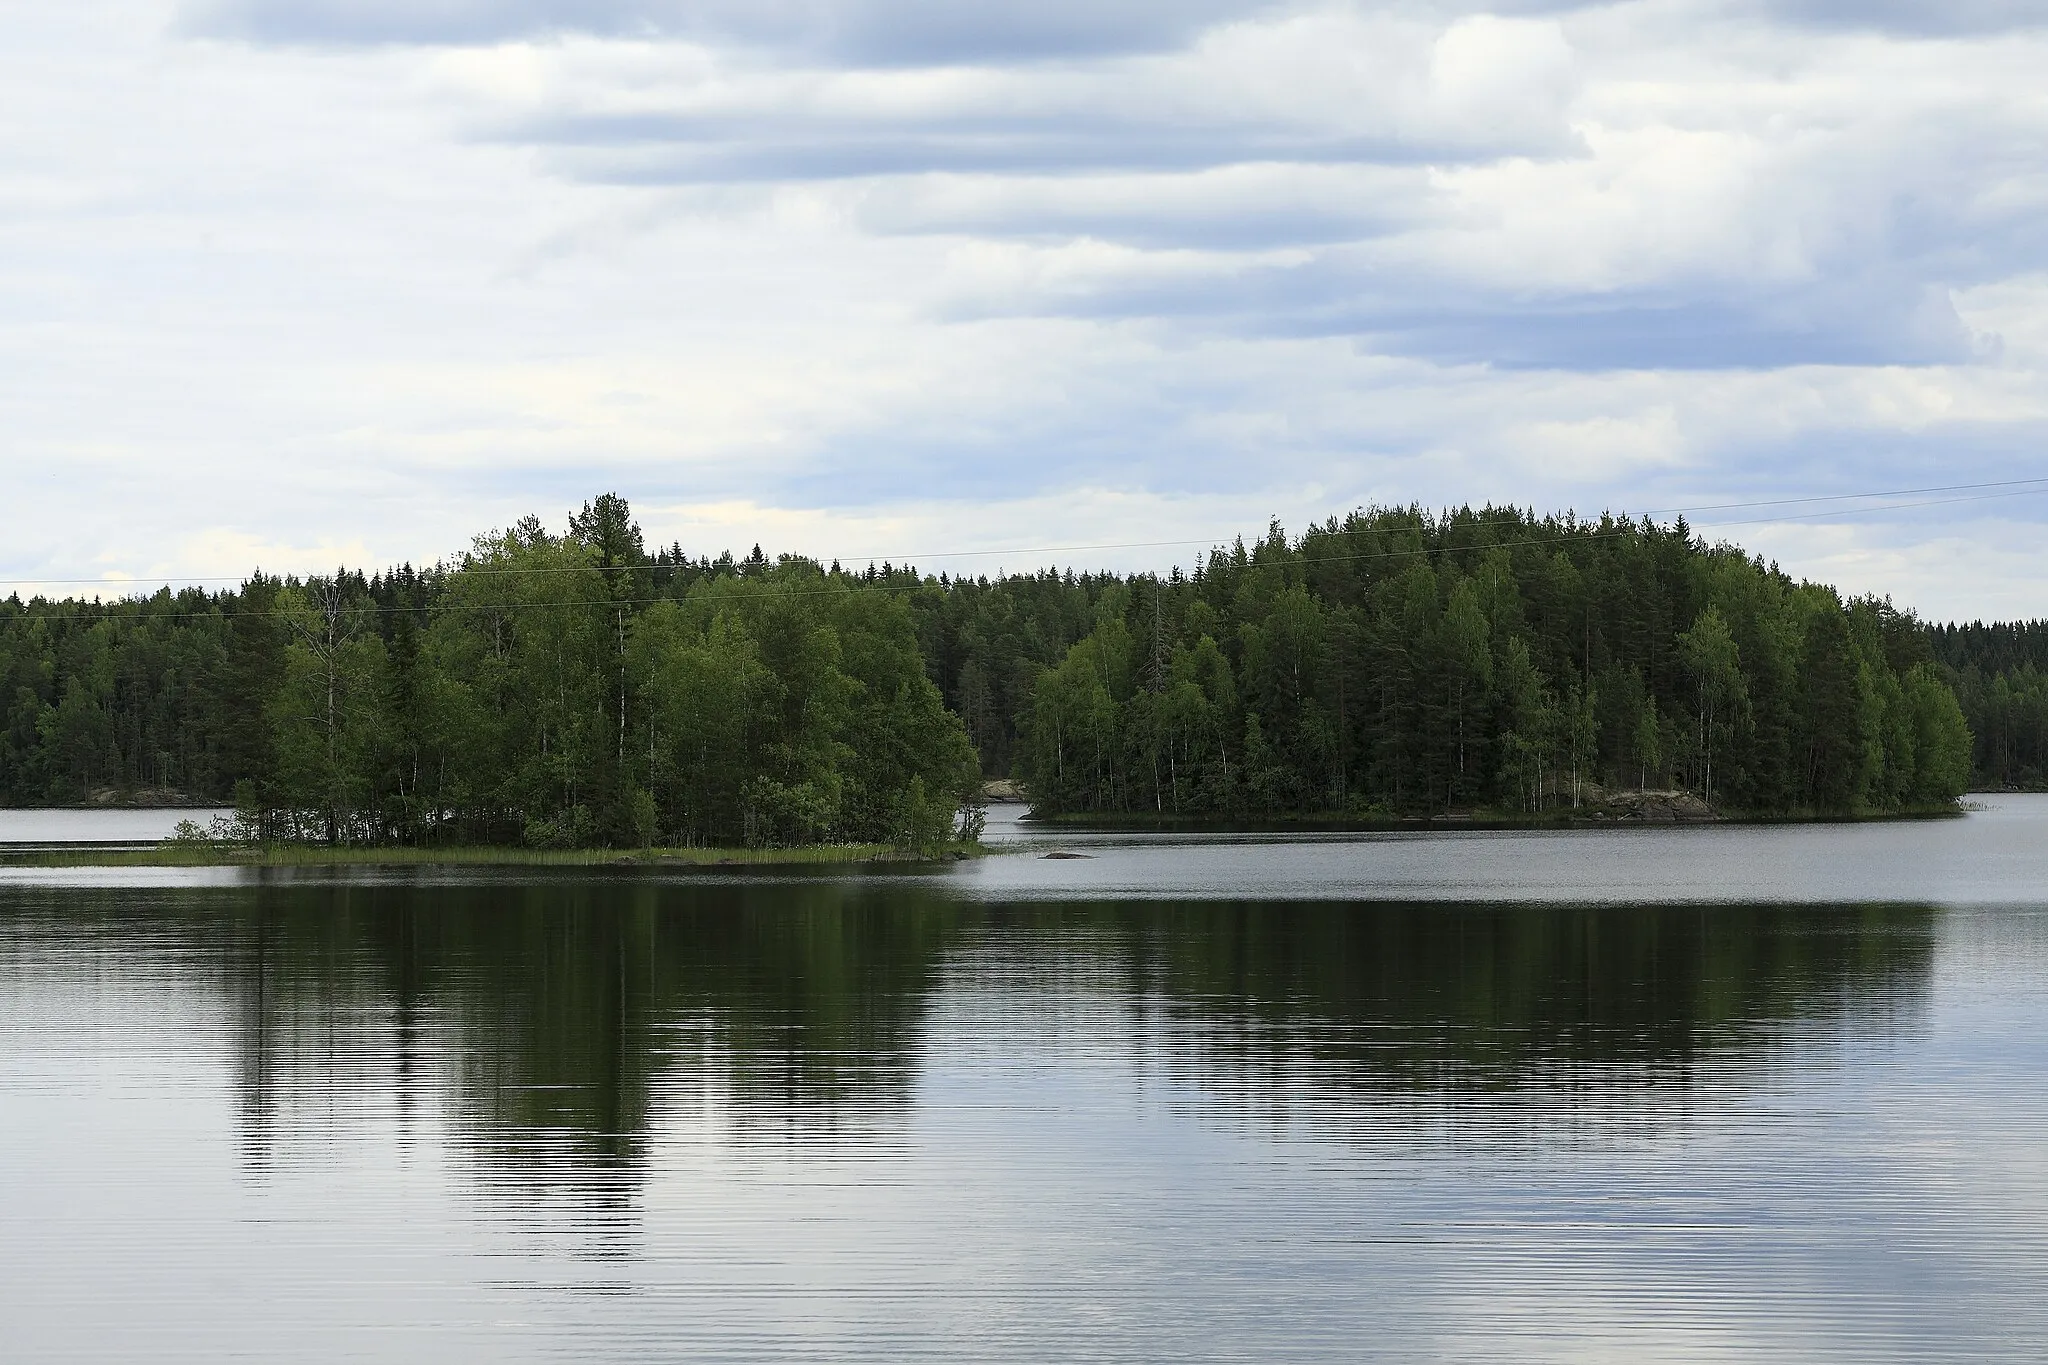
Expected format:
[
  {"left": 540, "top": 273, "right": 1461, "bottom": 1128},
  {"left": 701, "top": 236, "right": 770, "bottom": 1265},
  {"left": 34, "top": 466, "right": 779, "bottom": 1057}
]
[{"left": 0, "top": 495, "right": 979, "bottom": 847}]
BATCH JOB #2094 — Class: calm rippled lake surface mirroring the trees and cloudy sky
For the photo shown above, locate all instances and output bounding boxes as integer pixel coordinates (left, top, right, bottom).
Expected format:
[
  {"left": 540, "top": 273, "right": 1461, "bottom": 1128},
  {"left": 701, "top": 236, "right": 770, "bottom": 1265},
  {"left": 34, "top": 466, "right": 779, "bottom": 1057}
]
[{"left": 0, "top": 798, "right": 2048, "bottom": 1361}]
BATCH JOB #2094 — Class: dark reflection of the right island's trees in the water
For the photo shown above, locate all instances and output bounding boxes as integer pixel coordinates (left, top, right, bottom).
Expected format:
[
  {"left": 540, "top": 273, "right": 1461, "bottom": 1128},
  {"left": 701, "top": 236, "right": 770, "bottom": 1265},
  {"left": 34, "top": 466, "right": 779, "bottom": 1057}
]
[{"left": 1020, "top": 902, "right": 1937, "bottom": 1089}]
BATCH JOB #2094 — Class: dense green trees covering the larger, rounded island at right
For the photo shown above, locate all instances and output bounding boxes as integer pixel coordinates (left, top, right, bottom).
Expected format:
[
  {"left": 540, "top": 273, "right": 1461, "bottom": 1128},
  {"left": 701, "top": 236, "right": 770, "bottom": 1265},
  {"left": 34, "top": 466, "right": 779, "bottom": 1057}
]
[{"left": 911, "top": 508, "right": 1970, "bottom": 817}]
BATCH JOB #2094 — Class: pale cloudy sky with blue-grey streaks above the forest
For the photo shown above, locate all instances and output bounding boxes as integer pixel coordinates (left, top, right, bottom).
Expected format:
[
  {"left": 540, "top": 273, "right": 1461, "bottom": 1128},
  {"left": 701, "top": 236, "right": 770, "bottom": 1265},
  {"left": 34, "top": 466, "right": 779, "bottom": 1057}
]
[{"left": 0, "top": 0, "right": 2048, "bottom": 618}]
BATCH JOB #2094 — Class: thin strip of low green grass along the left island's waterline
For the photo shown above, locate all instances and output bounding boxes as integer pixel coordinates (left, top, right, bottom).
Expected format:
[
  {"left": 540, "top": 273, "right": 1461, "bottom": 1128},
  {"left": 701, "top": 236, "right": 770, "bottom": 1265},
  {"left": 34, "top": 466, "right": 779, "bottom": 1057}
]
[{"left": 0, "top": 841, "right": 987, "bottom": 872}]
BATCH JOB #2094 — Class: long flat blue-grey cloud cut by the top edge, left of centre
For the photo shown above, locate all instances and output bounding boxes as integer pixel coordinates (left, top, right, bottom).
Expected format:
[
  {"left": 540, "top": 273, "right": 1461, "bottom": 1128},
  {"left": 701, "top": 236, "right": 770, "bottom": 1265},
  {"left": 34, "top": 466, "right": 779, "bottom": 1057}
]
[{"left": 184, "top": 0, "right": 1274, "bottom": 65}]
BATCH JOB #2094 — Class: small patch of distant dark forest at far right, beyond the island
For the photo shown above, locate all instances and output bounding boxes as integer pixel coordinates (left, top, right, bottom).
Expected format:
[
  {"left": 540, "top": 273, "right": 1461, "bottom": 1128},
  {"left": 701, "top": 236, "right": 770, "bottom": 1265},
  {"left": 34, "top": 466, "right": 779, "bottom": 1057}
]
[{"left": 1929, "top": 620, "right": 2048, "bottom": 792}]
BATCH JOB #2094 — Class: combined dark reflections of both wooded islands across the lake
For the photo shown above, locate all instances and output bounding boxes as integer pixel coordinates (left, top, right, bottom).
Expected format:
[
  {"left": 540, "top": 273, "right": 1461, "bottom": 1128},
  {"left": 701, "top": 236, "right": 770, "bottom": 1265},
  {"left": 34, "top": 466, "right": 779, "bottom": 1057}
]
[{"left": 8, "top": 880, "right": 1935, "bottom": 1178}]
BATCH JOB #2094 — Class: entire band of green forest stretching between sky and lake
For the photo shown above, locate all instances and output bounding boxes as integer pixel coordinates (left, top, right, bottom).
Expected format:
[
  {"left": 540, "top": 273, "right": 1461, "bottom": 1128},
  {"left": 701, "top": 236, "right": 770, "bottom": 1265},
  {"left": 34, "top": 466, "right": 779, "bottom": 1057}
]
[{"left": 0, "top": 495, "right": 1990, "bottom": 847}]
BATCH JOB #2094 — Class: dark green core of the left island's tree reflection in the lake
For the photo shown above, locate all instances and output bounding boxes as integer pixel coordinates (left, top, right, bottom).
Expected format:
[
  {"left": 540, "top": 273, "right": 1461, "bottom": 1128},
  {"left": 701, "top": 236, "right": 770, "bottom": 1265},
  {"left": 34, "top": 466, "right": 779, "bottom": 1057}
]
[{"left": 252, "top": 882, "right": 952, "bottom": 1164}]
